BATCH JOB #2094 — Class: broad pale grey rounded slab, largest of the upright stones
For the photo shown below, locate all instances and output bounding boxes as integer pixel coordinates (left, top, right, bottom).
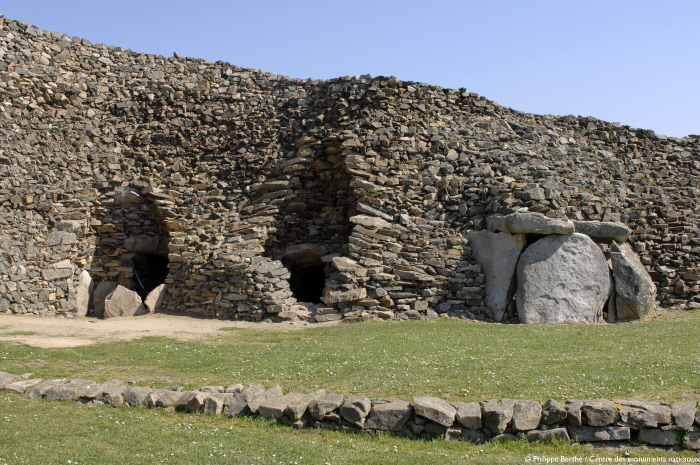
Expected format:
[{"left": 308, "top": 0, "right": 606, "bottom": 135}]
[{"left": 516, "top": 233, "right": 610, "bottom": 324}]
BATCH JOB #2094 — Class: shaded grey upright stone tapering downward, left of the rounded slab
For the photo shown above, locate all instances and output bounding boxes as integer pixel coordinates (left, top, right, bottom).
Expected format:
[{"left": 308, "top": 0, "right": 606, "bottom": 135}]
[{"left": 469, "top": 230, "right": 527, "bottom": 321}]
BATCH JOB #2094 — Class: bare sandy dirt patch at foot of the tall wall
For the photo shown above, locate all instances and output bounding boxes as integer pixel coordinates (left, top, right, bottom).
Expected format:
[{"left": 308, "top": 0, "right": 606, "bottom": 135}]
[{"left": 0, "top": 313, "right": 336, "bottom": 348}]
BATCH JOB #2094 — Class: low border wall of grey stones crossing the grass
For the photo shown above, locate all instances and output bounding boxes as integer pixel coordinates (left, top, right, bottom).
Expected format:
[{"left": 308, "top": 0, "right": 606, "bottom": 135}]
[{"left": 0, "top": 372, "right": 700, "bottom": 450}]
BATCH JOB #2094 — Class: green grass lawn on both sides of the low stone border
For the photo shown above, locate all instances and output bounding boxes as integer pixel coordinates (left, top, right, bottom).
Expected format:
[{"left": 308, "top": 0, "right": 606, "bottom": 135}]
[{"left": 0, "top": 312, "right": 700, "bottom": 465}]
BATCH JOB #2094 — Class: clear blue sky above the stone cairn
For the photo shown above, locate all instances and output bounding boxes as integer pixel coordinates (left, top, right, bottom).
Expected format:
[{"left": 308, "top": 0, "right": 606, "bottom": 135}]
[{"left": 0, "top": 0, "right": 700, "bottom": 137}]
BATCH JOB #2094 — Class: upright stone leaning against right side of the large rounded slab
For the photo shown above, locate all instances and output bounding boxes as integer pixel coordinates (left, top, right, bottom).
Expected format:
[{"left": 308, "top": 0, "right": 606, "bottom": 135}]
[{"left": 610, "top": 242, "right": 656, "bottom": 320}]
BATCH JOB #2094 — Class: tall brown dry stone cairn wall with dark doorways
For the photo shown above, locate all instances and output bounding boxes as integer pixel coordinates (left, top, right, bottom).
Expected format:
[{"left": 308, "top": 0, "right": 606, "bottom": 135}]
[{"left": 0, "top": 18, "right": 700, "bottom": 321}]
